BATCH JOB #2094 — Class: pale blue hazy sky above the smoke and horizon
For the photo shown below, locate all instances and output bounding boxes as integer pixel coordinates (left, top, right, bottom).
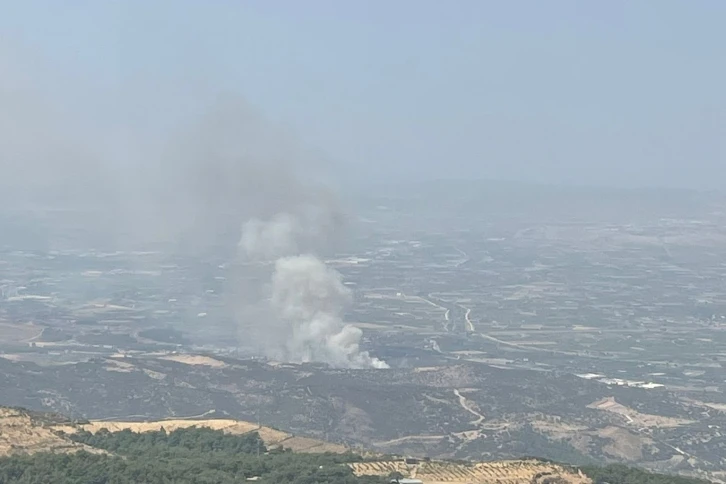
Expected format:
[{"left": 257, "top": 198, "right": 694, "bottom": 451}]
[{"left": 0, "top": 0, "right": 726, "bottom": 188}]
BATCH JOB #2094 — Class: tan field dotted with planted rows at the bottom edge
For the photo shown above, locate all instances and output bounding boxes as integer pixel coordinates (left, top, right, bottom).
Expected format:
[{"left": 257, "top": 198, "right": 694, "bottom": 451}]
[{"left": 350, "top": 460, "right": 592, "bottom": 484}]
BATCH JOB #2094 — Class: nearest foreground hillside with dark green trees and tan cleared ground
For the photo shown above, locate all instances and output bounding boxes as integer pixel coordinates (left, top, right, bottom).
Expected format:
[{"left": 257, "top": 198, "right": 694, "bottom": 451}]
[{"left": 0, "top": 408, "right": 706, "bottom": 484}]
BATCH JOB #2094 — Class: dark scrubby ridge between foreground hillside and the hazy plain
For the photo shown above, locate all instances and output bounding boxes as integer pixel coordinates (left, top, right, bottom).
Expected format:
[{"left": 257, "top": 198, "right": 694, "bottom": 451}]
[{"left": 0, "top": 355, "right": 726, "bottom": 481}]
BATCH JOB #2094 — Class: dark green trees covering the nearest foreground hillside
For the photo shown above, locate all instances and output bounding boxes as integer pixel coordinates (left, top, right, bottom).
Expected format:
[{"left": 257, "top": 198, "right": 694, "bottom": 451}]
[{"left": 0, "top": 427, "right": 706, "bottom": 484}]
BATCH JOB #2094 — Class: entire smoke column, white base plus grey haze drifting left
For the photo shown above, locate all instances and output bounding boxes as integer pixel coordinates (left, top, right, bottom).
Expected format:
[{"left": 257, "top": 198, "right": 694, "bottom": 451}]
[{"left": 0, "top": 43, "right": 386, "bottom": 368}]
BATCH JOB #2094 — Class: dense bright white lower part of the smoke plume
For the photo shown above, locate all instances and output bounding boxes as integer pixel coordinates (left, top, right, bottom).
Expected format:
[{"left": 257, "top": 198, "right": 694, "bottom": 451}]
[{"left": 240, "top": 212, "right": 388, "bottom": 368}]
